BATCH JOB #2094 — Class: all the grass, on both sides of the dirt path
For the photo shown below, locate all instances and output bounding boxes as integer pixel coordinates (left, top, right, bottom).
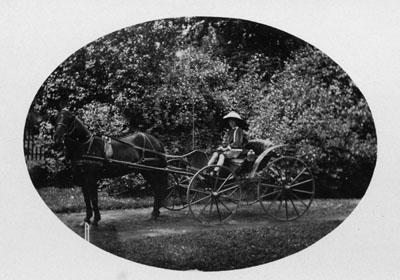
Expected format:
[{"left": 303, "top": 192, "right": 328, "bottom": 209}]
[{"left": 38, "top": 188, "right": 359, "bottom": 271}]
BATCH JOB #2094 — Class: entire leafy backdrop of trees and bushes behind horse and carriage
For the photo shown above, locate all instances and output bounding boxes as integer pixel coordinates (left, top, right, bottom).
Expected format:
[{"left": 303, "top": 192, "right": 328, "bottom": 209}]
[{"left": 26, "top": 18, "right": 376, "bottom": 196}]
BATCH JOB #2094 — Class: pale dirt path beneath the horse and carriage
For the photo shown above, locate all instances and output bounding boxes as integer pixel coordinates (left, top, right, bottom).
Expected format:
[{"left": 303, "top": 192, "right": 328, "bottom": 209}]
[{"left": 57, "top": 200, "right": 358, "bottom": 242}]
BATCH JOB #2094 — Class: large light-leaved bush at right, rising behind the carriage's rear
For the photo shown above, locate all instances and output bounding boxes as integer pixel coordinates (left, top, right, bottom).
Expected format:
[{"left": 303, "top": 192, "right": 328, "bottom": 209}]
[{"left": 250, "top": 47, "right": 376, "bottom": 196}]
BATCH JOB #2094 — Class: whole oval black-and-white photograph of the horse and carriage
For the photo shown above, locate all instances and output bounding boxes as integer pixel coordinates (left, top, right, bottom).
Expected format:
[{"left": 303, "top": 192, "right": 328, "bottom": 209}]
[{"left": 23, "top": 17, "right": 377, "bottom": 271}]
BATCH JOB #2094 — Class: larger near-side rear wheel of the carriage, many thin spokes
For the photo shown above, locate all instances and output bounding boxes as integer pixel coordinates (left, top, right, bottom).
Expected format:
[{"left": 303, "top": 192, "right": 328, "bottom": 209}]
[{"left": 257, "top": 156, "right": 315, "bottom": 221}]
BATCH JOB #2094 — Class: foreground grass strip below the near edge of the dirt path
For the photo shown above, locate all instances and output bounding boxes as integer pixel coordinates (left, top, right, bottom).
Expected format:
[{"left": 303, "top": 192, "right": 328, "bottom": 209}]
[{"left": 95, "top": 221, "right": 340, "bottom": 271}]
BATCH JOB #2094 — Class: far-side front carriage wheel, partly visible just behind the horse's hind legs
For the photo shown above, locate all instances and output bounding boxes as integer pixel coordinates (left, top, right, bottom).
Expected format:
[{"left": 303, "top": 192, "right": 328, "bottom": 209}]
[{"left": 163, "top": 159, "right": 191, "bottom": 211}]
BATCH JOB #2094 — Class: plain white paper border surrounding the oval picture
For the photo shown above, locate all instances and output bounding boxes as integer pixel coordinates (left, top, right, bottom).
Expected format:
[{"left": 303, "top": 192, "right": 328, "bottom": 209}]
[{"left": 0, "top": 0, "right": 400, "bottom": 279}]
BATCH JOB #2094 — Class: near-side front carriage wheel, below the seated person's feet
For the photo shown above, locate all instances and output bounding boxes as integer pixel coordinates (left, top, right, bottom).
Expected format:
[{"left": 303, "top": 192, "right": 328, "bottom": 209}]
[{"left": 187, "top": 165, "right": 241, "bottom": 224}]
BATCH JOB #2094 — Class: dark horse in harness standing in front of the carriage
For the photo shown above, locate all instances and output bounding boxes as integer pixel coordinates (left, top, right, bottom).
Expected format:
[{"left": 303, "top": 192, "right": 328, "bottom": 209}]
[{"left": 54, "top": 109, "right": 168, "bottom": 225}]
